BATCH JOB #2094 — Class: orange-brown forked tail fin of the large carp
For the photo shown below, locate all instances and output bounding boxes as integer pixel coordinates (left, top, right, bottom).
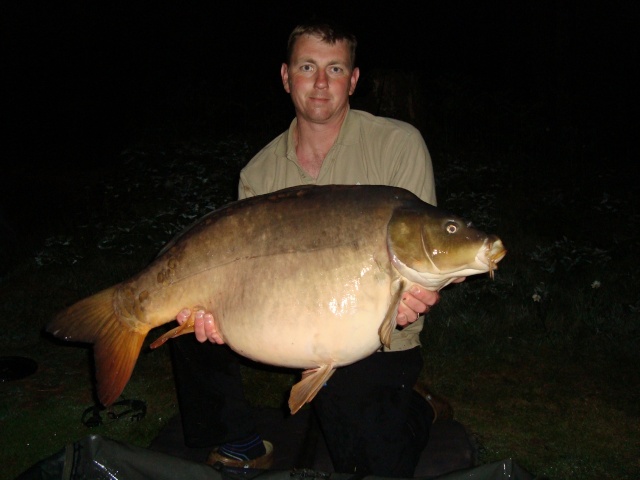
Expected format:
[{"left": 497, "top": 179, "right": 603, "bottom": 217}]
[{"left": 47, "top": 287, "right": 149, "bottom": 406}]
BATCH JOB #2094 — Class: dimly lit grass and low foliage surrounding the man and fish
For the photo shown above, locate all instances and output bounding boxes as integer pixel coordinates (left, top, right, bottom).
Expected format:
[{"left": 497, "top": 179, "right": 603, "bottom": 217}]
[{"left": 0, "top": 106, "right": 640, "bottom": 479}]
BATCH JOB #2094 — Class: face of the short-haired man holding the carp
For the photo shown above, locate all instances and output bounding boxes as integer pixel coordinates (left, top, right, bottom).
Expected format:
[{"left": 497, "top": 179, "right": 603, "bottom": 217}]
[{"left": 280, "top": 35, "right": 360, "bottom": 123}]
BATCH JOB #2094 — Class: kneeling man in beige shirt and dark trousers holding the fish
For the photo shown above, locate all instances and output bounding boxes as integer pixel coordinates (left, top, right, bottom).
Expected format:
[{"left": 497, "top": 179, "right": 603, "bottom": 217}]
[{"left": 174, "top": 24, "right": 452, "bottom": 477}]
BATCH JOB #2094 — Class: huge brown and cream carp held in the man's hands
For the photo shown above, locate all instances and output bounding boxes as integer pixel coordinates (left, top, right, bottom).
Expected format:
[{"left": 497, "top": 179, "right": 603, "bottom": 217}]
[{"left": 47, "top": 185, "right": 506, "bottom": 413}]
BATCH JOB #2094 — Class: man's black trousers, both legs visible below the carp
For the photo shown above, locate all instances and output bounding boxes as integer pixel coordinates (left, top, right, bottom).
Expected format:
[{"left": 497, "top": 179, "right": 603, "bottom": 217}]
[{"left": 171, "top": 335, "right": 433, "bottom": 477}]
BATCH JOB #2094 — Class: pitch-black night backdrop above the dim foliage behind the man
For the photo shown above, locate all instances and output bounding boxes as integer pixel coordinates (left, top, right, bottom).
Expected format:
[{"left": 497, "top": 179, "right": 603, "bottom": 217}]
[{"left": 0, "top": 0, "right": 639, "bottom": 226}]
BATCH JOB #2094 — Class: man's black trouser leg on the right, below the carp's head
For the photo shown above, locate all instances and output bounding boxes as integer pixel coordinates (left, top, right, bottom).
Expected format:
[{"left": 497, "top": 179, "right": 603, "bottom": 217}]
[{"left": 312, "top": 347, "right": 433, "bottom": 478}]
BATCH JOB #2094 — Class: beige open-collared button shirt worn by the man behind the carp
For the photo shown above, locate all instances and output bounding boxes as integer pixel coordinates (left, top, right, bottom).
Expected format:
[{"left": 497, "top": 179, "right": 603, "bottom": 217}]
[{"left": 238, "top": 110, "right": 436, "bottom": 351}]
